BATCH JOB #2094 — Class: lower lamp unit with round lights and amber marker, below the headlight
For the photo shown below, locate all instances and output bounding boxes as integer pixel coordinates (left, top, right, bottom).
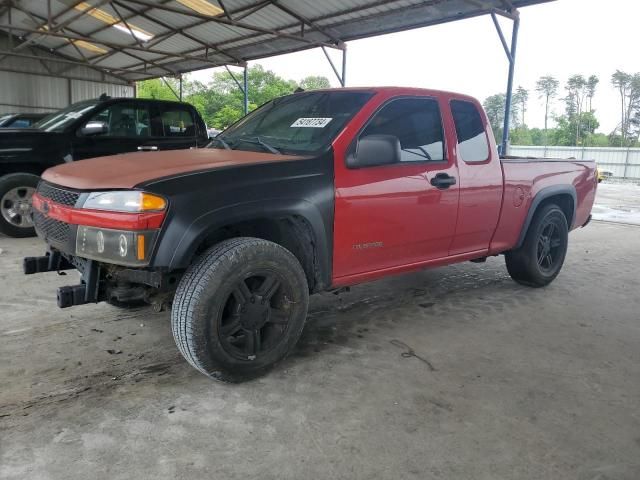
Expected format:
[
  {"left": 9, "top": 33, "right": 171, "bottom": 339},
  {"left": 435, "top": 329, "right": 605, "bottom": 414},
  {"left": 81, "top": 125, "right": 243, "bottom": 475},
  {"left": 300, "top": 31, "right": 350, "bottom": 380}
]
[{"left": 76, "top": 225, "right": 157, "bottom": 267}]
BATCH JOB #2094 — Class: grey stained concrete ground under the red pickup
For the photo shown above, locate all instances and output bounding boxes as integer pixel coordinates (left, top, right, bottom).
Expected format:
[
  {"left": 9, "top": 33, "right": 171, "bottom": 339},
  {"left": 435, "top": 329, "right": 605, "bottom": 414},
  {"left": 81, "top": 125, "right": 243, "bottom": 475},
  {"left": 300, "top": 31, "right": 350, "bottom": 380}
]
[{"left": 0, "top": 213, "right": 640, "bottom": 480}]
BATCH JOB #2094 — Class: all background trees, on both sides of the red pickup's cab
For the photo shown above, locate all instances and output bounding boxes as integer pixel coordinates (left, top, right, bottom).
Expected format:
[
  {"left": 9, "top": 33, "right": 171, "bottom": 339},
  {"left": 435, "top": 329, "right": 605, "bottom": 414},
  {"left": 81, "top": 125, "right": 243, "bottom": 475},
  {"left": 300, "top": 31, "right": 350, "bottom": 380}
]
[{"left": 137, "top": 65, "right": 640, "bottom": 147}]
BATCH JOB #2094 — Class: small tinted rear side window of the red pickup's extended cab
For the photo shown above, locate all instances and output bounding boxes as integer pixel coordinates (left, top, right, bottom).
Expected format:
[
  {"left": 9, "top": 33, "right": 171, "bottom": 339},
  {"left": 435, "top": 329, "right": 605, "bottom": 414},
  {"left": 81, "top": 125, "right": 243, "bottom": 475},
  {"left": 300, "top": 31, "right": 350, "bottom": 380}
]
[{"left": 450, "top": 100, "right": 489, "bottom": 163}]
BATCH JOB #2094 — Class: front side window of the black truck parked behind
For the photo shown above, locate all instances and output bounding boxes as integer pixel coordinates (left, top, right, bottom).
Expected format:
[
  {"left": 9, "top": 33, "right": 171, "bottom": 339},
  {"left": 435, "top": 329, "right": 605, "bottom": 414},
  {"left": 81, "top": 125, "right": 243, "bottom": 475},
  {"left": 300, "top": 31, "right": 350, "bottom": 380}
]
[{"left": 83, "top": 103, "right": 151, "bottom": 138}]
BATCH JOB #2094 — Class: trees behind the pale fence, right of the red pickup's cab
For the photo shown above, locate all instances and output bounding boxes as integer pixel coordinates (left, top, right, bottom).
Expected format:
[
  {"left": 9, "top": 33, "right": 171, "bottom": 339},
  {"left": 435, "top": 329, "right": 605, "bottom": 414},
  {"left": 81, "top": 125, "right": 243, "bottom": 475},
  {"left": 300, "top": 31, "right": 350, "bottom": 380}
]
[{"left": 483, "top": 70, "right": 640, "bottom": 147}]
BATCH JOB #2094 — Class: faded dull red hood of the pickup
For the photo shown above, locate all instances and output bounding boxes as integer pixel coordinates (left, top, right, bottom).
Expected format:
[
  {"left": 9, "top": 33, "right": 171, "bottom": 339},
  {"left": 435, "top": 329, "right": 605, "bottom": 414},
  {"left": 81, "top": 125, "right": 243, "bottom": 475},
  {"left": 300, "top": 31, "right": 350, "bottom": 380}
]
[{"left": 42, "top": 148, "right": 304, "bottom": 190}]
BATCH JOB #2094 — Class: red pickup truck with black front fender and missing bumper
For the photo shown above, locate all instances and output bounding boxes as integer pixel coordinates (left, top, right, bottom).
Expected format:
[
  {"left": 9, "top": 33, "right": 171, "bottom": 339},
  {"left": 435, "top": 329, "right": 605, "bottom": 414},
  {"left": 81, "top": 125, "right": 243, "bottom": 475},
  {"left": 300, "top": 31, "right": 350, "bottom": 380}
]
[{"left": 24, "top": 88, "right": 597, "bottom": 381}]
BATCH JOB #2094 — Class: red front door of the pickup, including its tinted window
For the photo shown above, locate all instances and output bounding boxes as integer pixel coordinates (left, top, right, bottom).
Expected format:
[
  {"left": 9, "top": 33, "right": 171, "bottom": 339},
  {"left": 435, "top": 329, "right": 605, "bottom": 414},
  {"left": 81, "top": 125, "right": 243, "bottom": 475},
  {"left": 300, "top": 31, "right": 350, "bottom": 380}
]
[{"left": 333, "top": 96, "right": 459, "bottom": 285}]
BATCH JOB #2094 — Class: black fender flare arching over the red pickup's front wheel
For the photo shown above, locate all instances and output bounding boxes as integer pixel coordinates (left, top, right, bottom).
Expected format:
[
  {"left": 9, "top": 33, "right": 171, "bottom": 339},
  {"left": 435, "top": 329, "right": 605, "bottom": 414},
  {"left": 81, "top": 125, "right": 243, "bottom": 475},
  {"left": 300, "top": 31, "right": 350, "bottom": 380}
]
[{"left": 154, "top": 198, "right": 333, "bottom": 285}]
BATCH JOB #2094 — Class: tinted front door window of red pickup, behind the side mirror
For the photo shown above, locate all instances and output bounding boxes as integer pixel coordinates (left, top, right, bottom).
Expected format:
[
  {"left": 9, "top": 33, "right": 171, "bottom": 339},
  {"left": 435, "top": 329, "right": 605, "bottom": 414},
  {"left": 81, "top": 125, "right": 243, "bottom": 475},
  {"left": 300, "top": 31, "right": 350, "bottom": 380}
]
[{"left": 360, "top": 98, "right": 445, "bottom": 162}]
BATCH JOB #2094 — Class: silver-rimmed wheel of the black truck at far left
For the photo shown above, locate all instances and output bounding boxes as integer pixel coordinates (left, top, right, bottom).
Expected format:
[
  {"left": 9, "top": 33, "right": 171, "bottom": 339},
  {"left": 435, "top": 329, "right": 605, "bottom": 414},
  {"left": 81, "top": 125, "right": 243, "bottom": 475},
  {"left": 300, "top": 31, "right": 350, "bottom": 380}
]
[{"left": 0, "top": 173, "right": 40, "bottom": 238}]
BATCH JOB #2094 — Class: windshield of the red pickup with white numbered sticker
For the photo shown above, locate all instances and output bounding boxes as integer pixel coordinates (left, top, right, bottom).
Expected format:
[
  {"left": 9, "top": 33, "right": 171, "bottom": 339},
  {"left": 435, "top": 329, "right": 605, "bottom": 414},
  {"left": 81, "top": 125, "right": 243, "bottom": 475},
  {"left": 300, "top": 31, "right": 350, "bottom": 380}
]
[{"left": 216, "top": 91, "right": 373, "bottom": 154}]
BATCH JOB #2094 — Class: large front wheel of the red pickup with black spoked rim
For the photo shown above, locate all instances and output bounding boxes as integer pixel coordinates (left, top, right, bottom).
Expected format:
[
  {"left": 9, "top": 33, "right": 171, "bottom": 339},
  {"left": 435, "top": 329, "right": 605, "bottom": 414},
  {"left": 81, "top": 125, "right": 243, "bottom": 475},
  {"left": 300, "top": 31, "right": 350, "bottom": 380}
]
[{"left": 171, "top": 238, "right": 309, "bottom": 382}]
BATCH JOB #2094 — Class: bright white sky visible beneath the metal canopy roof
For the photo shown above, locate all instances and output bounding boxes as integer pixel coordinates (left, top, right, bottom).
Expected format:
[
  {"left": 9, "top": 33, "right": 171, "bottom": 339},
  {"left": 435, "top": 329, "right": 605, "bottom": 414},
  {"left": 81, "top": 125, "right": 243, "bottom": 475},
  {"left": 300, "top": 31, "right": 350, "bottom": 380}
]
[{"left": 191, "top": 0, "right": 640, "bottom": 134}]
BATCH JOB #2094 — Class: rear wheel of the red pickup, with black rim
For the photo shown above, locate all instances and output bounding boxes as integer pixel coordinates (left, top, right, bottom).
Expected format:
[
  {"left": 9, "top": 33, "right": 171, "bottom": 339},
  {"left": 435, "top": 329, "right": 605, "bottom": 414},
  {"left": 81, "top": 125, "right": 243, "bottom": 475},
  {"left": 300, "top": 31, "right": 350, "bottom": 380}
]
[{"left": 505, "top": 204, "right": 569, "bottom": 287}]
